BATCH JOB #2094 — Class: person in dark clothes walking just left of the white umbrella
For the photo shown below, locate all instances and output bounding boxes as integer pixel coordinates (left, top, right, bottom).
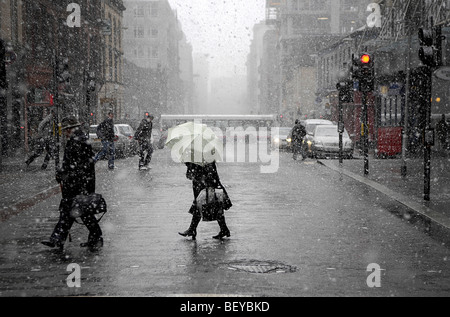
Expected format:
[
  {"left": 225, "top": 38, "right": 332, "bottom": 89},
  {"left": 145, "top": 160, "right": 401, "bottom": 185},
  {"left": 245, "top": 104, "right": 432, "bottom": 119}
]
[{"left": 134, "top": 114, "right": 154, "bottom": 170}]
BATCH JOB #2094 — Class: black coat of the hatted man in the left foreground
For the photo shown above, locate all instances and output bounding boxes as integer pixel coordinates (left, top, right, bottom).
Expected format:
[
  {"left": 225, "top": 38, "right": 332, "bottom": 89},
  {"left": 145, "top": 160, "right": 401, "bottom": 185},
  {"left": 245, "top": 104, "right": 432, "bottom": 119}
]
[{"left": 56, "top": 129, "right": 95, "bottom": 199}]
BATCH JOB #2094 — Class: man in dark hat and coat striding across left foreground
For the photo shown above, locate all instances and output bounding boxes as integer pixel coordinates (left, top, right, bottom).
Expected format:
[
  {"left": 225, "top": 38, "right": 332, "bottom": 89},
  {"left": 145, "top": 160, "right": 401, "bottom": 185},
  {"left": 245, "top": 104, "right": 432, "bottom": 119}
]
[{"left": 41, "top": 117, "right": 103, "bottom": 250}]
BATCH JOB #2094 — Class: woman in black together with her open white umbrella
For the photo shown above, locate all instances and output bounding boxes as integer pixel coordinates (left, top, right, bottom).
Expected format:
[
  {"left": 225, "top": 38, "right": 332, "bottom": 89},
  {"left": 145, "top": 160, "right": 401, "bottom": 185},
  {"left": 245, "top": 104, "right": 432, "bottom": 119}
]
[{"left": 166, "top": 122, "right": 232, "bottom": 240}]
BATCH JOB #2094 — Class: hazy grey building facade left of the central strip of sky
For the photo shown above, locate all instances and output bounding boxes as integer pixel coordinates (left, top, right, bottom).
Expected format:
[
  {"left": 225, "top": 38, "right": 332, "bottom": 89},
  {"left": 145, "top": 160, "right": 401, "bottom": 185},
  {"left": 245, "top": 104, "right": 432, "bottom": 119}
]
[{"left": 124, "top": 0, "right": 192, "bottom": 115}]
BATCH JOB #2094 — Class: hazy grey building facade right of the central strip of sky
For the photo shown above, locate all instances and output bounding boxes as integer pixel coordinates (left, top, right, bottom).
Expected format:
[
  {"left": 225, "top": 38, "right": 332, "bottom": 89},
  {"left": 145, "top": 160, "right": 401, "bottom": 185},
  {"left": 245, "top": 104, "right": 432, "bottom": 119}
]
[{"left": 265, "top": 0, "right": 372, "bottom": 123}]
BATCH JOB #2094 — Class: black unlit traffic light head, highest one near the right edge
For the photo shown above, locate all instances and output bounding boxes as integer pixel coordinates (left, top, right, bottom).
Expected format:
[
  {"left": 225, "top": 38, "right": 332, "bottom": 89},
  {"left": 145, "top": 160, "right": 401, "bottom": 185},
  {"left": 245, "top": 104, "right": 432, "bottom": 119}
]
[{"left": 419, "top": 26, "right": 442, "bottom": 67}]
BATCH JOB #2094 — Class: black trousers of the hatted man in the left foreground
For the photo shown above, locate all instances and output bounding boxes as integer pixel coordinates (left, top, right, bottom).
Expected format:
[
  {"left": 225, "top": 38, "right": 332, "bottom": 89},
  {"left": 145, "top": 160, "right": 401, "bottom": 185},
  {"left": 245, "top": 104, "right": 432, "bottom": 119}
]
[{"left": 50, "top": 198, "right": 103, "bottom": 244}]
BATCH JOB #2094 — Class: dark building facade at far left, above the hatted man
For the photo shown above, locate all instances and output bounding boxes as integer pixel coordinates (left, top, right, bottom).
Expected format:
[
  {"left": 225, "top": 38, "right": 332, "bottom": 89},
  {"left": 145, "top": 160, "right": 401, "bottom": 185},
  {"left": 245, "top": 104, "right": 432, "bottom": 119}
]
[{"left": 0, "top": 0, "right": 108, "bottom": 154}]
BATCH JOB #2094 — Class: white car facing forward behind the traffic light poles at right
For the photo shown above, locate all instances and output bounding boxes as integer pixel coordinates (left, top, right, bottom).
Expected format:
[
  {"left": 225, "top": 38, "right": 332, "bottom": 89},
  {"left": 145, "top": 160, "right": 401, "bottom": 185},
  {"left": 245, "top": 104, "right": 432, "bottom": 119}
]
[{"left": 311, "top": 125, "right": 353, "bottom": 158}]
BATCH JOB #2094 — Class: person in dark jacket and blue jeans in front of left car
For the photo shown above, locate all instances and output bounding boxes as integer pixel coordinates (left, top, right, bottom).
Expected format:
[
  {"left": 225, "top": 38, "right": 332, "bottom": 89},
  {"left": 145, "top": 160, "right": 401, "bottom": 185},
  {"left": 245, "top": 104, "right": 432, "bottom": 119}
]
[{"left": 94, "top": 111, "right": 116, "bottom": 170}]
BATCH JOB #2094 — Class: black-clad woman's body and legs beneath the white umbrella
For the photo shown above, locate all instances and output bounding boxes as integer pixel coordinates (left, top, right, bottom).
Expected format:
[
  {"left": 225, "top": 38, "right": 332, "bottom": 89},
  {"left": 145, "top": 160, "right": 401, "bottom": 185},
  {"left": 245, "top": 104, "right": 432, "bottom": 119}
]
[{"left": 179, "top": 162, "right": 232, "bottom": 240}]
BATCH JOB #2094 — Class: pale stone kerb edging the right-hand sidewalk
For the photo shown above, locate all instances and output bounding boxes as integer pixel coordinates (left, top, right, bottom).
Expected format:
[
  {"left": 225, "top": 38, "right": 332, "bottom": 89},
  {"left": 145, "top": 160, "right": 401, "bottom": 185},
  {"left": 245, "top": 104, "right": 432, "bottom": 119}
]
[{"left": 317, "top": 160, "right": 450, "bottom": 244}]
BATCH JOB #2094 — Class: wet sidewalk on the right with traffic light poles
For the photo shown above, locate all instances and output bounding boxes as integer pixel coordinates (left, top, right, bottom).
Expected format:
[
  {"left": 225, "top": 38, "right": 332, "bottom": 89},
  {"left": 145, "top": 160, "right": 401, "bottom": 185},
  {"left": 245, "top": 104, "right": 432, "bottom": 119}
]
[{"left": 319, "top": 155, "right": 450, "bottom": 240}]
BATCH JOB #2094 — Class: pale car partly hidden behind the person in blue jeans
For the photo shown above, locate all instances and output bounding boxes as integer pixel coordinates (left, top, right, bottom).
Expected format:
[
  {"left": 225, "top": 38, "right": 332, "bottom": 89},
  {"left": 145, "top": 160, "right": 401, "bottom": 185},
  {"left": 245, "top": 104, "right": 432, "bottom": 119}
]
[{"left": 89, "top": 124, "right": 136, "bottom": 157}]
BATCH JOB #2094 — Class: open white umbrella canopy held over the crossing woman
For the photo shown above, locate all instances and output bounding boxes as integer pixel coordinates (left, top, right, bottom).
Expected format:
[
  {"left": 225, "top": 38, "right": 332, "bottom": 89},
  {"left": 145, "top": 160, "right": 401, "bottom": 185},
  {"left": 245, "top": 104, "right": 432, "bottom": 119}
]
[{"left": 166, "top": 122, "right": 223, "bottom": 165}]
